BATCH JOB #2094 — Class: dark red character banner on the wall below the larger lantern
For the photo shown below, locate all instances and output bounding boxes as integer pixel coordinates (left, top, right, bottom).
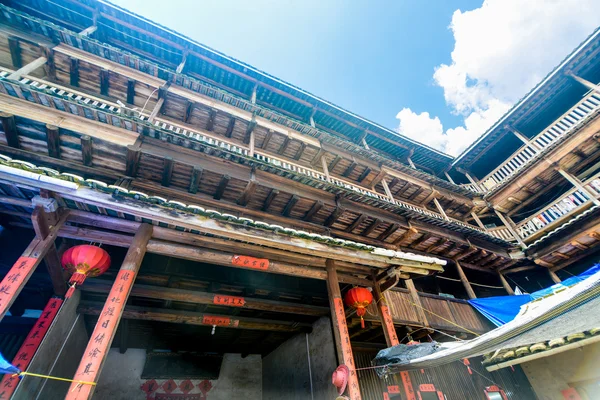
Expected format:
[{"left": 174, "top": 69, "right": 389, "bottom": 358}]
[{"left": 0, "top": 297, "right": 63, "bottom": 399}]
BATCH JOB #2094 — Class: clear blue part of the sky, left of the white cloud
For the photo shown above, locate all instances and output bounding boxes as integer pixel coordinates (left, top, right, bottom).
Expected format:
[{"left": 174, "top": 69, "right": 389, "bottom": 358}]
[{"left": 114, "top": 0, "right": 481, "bottom": 128}]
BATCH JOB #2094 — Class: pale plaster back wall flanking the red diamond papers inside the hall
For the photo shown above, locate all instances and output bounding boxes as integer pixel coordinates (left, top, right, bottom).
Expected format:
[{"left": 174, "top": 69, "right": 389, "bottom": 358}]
[{"left": 93, "top": 349, "right": 262, "bottom": 400}]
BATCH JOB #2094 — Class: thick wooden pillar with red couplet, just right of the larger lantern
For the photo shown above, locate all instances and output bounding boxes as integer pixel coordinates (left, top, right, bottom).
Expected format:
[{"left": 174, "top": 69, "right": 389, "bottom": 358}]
[{"left": 65, "top": 224, "right": 152, "bottom": 400}]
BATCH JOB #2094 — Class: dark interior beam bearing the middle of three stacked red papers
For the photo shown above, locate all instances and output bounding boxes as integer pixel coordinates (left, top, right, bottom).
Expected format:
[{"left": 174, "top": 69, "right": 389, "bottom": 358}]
[{"left": 81, "top": 279, "right": 329, "bottom": 316}]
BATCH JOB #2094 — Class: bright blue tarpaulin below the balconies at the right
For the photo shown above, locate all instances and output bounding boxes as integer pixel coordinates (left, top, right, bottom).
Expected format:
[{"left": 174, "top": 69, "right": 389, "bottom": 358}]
[{"left": 469, "top": 264, "right": 600, "bottom": 326}]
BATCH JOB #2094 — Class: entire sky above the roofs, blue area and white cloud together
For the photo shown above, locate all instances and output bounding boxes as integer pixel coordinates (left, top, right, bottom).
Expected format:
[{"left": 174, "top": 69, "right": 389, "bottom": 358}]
[{"left": 112, "top": 0, "right": 600, "bottom": 155}]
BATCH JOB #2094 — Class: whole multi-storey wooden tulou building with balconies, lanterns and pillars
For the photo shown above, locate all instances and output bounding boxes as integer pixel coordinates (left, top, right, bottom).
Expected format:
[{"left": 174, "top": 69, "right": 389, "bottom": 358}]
[{"left": 0, "top": 0, "right": 600, "bottom": 400}]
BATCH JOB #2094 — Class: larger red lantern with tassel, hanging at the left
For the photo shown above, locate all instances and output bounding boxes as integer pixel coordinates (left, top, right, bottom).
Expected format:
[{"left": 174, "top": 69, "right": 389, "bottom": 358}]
[{"left": 61, "top": 244, "right": 110, "bottom": 298}]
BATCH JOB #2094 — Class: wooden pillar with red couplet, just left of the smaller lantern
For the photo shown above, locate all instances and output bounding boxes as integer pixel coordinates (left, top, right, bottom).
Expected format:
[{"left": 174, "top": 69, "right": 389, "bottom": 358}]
[{"left": 326, "top": 260, "right": 361, "bottom": 400}]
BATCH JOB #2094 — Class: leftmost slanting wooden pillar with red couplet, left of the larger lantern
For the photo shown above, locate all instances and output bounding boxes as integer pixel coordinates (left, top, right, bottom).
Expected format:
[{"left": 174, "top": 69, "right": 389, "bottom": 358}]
[{"left": 0, "top": 212, "right": 68, "bottom": 320}]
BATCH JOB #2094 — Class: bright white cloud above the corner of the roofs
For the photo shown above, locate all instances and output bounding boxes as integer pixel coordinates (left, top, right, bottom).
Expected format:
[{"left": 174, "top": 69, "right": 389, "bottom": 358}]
[{"left": 396, "top": 0, "right": 600, "bottom": 155}]
